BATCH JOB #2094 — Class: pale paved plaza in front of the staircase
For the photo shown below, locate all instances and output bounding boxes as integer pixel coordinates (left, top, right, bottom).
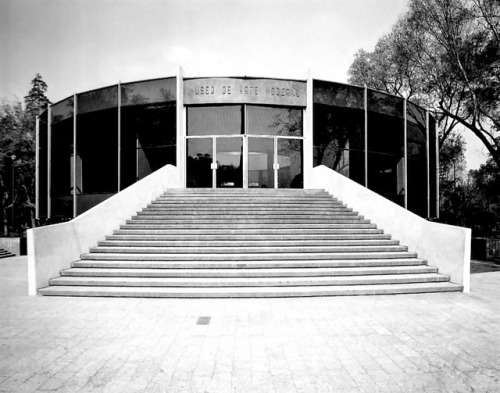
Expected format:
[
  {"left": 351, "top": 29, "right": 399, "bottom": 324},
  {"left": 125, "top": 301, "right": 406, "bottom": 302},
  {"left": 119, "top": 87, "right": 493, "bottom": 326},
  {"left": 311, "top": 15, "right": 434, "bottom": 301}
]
[{"left": 0, "top": 257, "right": 500, "bottom": 393}]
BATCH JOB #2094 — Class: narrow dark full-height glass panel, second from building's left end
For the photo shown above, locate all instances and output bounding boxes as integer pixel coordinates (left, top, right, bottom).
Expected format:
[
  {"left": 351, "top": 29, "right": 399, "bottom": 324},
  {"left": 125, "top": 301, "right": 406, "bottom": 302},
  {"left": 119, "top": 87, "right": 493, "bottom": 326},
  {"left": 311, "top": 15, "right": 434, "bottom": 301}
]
[{"left": 50, "top": 97, "right": 74, "bottom": 220}]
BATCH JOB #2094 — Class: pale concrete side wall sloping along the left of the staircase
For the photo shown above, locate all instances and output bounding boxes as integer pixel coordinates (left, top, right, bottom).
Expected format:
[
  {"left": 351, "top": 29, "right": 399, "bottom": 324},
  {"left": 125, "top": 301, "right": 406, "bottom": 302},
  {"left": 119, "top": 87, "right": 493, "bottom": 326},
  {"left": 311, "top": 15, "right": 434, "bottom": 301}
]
[{"left": 27, "top": 165, "right": 181, "bottom": 295}]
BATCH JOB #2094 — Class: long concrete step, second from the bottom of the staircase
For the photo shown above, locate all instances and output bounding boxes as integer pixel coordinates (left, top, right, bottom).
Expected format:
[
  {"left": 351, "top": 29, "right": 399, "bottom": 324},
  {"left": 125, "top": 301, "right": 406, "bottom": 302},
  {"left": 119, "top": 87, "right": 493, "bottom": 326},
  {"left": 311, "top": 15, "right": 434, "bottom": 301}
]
[{"left": 49, "top": 273, "right": 449, "bottom": 288}]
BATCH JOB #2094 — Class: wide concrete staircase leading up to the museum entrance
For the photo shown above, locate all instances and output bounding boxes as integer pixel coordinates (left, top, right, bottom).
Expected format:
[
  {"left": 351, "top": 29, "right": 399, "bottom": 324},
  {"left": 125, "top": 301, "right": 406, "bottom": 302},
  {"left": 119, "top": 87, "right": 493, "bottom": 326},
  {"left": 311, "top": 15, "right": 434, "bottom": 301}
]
[{"left": 40, "top": 189, "right": 462, "bottom": 298}]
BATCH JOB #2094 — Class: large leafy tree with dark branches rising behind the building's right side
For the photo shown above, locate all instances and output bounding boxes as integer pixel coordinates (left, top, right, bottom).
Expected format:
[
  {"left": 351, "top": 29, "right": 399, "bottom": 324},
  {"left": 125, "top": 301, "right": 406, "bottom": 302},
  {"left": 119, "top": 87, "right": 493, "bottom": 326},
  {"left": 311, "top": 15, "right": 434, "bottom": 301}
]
[{"left": 349, "top": 0, "right": 500, "bottom": 168}]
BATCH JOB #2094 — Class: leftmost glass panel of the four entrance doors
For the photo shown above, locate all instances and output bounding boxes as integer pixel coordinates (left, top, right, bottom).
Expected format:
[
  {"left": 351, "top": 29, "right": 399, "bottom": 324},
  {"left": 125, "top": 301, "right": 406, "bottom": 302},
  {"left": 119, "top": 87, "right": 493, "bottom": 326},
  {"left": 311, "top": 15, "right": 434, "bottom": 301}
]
[{"left": 186, "top": 138, "right": 213, "bottom": 187}]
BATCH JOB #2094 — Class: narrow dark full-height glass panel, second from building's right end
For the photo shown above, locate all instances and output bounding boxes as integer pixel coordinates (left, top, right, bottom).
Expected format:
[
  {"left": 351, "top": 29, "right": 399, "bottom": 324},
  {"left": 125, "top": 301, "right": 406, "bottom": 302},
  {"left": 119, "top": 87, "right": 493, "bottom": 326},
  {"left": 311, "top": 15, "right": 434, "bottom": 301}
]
[{"left": 406, "top": 102, "right": 427, "bottom": 217}]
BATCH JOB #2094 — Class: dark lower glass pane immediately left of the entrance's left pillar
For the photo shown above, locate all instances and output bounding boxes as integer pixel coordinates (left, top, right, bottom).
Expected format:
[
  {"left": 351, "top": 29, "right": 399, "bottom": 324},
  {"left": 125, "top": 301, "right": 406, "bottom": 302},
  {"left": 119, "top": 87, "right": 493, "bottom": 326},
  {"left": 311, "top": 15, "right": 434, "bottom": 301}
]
[{"left": 121, "top": 104, "right": 176, "bottom": 189}]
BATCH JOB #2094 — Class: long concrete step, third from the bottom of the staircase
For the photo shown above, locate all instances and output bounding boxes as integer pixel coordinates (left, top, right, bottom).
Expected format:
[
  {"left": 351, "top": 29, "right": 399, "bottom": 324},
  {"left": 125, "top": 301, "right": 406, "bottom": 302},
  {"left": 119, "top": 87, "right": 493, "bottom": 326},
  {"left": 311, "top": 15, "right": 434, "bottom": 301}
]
[{"left": 61, "top": 265, "right": 437, "bottom": 278}]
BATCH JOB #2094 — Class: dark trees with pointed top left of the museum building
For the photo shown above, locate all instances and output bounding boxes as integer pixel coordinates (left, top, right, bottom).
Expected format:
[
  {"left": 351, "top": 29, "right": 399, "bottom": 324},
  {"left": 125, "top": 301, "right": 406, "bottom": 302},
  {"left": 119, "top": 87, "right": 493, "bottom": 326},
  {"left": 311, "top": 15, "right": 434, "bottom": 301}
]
[{"left": 0, "top": 74, "right": 50, "bottom": 234}]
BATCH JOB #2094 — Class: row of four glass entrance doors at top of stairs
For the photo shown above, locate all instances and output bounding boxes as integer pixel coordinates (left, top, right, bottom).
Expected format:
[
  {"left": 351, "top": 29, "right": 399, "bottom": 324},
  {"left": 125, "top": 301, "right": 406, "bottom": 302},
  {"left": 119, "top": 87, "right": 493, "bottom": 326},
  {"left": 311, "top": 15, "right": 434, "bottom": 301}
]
[{"left": 186, "top": 135, "right": 303, "bottom": 188}]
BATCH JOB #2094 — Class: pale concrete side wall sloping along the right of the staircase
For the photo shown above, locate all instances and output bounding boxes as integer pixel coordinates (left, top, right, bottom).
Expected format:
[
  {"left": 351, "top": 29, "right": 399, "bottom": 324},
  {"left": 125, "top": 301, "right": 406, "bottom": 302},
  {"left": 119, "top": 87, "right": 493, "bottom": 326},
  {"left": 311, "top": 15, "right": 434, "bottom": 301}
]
[{"left": 310, "top": 165, "right": 471, "bottom": 292}]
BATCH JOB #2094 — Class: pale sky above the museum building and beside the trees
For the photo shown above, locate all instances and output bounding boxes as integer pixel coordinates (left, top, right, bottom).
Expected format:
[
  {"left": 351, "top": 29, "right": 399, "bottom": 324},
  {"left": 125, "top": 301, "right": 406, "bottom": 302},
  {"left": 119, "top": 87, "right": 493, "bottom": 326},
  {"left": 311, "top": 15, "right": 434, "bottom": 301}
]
[{"left": 0, "top": 0, "right": 485, "bottom": 169}]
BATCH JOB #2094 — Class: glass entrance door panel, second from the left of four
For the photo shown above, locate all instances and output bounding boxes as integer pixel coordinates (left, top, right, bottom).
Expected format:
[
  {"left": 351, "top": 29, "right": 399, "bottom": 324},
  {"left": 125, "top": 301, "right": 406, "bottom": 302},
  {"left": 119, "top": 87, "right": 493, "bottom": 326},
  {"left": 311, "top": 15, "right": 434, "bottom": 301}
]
[{"left": 216, "top": 137, "right": 243, "bottom": 188}]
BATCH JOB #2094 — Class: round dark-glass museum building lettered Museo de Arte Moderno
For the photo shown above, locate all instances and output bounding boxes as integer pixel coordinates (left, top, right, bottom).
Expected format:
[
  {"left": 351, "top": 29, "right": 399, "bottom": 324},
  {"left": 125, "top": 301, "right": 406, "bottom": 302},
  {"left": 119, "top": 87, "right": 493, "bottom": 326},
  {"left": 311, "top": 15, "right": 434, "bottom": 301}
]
[{"left": 36, "top": 72, "right": 439, "bottom": 222}]
